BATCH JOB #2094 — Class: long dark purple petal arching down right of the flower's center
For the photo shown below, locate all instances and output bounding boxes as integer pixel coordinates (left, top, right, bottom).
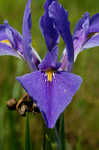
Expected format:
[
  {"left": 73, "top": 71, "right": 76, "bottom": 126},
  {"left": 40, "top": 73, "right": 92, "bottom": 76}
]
[{"left": 49, "top": 1, "right": 74, "bottom": 71}]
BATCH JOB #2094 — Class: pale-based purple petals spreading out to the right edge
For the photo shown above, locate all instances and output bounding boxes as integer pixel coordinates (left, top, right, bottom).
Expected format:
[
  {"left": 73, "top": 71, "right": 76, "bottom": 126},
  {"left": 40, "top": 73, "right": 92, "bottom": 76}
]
[{"left": 73, "top": 13, "right": 99, "bottom": 60}]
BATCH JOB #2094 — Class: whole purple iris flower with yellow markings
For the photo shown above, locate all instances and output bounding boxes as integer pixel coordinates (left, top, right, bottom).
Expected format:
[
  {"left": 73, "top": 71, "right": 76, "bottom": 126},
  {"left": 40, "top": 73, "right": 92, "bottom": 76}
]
[{"left": 0, "top": 0, "right": 99, "bottom": 128}]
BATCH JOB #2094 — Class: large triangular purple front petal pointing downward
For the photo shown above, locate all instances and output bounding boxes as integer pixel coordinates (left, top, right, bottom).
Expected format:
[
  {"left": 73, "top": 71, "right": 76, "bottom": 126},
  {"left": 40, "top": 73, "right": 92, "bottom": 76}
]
[{"left": 17, "top": 71, "right": 82, "bottom": 128}]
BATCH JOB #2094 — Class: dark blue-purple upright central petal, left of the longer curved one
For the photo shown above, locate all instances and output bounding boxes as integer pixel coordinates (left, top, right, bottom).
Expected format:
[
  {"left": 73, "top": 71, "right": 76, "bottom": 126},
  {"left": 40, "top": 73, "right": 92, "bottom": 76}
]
[{"left": 40, "top": 11, "right": 59, "bottom": 51}]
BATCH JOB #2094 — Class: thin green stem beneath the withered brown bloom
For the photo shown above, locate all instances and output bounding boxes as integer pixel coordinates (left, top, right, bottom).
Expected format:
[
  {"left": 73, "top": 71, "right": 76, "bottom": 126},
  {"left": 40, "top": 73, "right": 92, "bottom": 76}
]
[{"left": 25, "top": 112, "right": 31, "bottom": 150}]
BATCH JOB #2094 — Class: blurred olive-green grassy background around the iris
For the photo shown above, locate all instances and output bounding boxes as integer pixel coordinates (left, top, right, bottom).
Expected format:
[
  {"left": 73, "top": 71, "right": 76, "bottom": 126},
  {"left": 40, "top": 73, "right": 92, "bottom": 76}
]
[{"left": 0, "top": 0, "right": 99, "bottom": 150}]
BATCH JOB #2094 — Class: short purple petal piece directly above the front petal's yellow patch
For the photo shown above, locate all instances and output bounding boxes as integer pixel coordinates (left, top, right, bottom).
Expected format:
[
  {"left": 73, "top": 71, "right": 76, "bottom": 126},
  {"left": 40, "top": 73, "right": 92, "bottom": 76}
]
[{"left": 39, "top": 46, "right": 58, "bottom": 71}]
